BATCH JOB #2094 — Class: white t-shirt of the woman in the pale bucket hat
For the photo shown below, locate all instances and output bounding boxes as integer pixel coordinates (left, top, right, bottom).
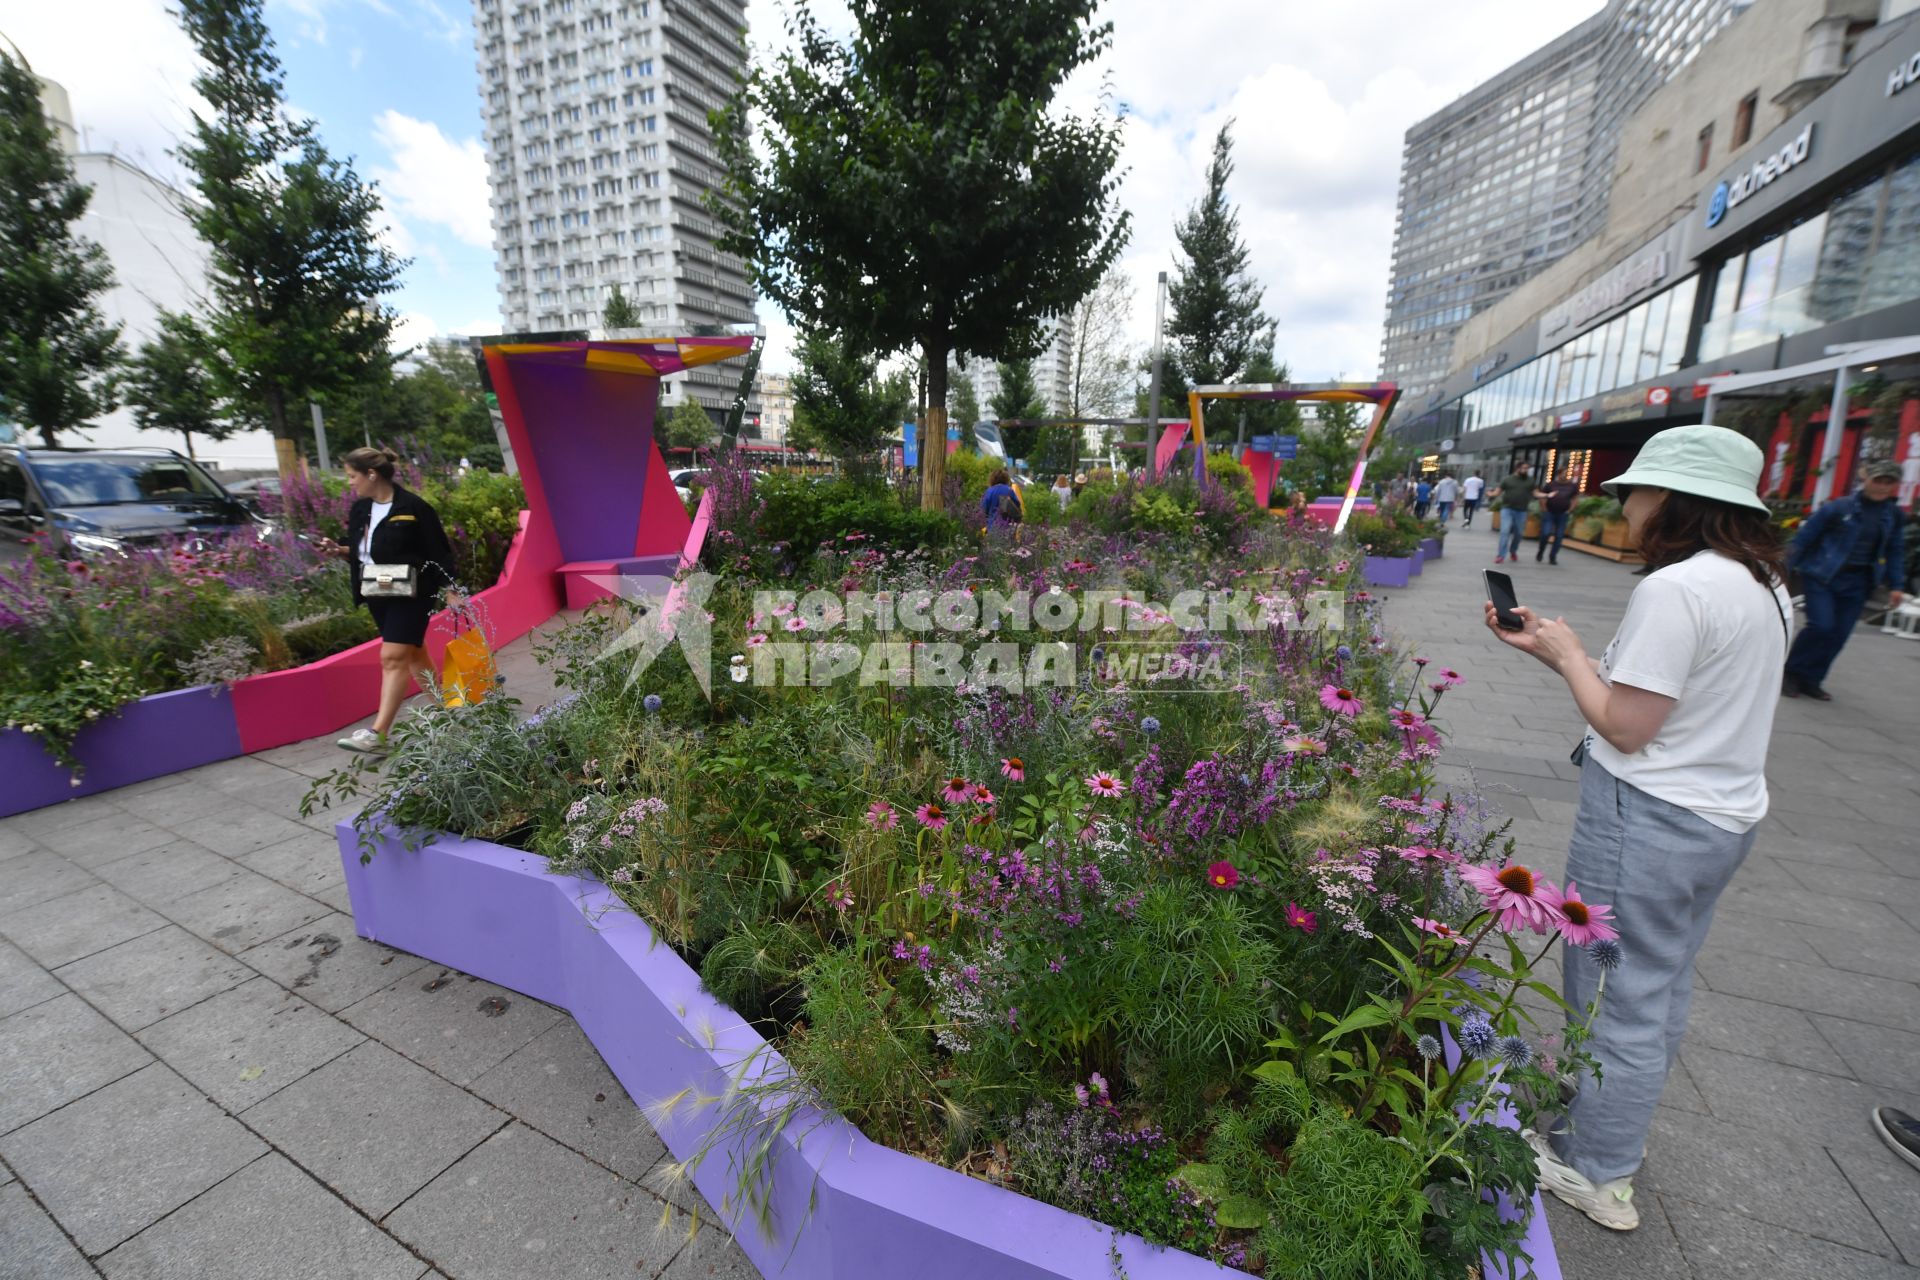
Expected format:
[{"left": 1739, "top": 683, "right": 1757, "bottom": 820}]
[{"left": 1586, "top": 551, "right": 1793, "bottom": 831}]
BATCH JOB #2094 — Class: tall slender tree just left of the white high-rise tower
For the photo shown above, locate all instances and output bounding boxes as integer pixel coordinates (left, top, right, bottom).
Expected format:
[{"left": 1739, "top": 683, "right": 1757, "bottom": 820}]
[{"left": 177, "top": 0, "right": 405, "bottom": 476}]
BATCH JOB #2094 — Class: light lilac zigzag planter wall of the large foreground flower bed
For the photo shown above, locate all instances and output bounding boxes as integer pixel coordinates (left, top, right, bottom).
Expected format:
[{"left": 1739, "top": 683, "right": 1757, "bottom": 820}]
[{"left": 338, "top": 823, "right": 1559, "bottom": 1280}]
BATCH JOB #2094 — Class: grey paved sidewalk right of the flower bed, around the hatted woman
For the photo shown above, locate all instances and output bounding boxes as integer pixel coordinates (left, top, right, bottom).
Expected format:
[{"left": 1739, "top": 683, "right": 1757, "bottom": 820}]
[{"left": 1386, "top": 518, "right": 1920, "bottom": 1280}]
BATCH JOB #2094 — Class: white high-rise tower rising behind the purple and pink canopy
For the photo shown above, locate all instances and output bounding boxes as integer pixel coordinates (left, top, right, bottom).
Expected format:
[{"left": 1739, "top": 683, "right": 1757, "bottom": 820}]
[{"left": 474, "top": 0, "right": 755, "bottom": 415}]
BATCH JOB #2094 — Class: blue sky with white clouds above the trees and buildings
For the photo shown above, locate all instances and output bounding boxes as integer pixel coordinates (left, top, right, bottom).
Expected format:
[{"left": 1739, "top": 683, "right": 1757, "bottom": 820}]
[{"left": 0, "top": 0, "right": 1599, "bottom": 382}]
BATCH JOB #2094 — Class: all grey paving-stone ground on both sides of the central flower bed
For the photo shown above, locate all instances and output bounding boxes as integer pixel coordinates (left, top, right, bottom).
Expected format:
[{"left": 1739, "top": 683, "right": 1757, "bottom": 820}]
[{"left": 0, "top": 518, "right": 1920, "bottom": 1280}]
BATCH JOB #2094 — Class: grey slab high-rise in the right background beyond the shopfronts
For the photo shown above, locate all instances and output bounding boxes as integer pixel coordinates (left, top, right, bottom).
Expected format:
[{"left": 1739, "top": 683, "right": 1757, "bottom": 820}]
[{"left": 1380, "top": 0, "right": 1753, "bottom": 405}]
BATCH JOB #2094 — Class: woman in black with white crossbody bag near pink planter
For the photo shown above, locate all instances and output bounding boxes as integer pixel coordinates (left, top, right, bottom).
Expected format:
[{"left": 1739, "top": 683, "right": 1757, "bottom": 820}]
[{"left": 336, "top": 449, "right": 455, "bottom": 754}]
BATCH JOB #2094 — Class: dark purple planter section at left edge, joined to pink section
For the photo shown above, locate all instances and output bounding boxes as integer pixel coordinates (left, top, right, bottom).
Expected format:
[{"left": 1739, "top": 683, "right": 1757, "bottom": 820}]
[{"left": 0, "top": 685, "right": 240, "bottom": 818}]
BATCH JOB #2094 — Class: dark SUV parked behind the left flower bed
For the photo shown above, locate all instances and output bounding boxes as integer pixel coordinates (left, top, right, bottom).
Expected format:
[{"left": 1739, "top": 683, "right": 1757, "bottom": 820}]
[{"left": 0, "top": 443, "right": 265, "bottom": 557}]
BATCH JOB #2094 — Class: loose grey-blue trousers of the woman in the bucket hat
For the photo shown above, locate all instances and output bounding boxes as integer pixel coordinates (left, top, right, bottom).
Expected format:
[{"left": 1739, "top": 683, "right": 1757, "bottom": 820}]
[{"left": 1551, "top": 756, "right": 1757, "bottom": 1182}]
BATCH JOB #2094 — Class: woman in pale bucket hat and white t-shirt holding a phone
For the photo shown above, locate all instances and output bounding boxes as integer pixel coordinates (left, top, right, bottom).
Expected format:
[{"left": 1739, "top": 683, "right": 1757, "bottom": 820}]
[{"left": 1486, "top": 426, "right": 1793, "bottom": 1230}]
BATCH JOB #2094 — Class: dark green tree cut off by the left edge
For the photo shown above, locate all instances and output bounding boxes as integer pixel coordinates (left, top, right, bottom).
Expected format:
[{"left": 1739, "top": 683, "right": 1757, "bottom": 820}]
[{"left": 0, "top": 52, "right": 125, "bottom": 445}]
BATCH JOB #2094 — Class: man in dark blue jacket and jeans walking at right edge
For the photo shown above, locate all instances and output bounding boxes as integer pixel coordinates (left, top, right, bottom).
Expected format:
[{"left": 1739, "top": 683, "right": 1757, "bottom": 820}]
[{"left": 1782, "top": 464, "right": 1907, "bottom": 702}]
